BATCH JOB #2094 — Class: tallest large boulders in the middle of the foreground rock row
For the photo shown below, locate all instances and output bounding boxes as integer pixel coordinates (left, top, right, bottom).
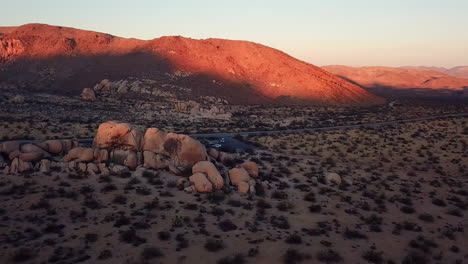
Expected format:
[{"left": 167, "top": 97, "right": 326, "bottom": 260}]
[{"left": 64, "top": 121, "right": 207, "bottom": 174}]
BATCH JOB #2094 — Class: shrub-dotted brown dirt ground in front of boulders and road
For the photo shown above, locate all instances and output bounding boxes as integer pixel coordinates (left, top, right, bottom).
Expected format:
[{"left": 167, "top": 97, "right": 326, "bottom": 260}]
[{"left": 0, "top": 118, "right": 468, "bottom": 263}]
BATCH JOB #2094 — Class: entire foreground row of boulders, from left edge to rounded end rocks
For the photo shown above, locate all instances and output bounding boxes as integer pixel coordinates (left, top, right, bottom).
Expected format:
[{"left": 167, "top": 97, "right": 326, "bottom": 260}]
[{"left": 0, "top": 121, "right": 259, "bottom": 193}]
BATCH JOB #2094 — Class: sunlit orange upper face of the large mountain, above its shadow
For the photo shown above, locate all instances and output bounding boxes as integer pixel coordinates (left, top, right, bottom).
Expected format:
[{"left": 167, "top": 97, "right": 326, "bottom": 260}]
[{"left": 0, "top": 24, "right": 384, "bottom": 104}]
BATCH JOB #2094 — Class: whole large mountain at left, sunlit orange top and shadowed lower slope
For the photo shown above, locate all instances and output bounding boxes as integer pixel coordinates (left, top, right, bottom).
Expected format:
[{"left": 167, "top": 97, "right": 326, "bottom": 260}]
[{"left": 0, "top": 24, "right": 385, "bottom": 105}]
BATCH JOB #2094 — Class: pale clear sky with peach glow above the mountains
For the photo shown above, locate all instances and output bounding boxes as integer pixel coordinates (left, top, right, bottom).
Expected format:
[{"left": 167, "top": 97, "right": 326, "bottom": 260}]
[{"left": 0, "top": 0, "right": 468, "bottom": 67}]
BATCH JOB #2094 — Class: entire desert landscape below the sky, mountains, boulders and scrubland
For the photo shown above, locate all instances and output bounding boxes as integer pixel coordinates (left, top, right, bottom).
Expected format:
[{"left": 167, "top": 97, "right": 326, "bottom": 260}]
[{"left": 0, "top": 19, "right": 468, "bottom": 264}]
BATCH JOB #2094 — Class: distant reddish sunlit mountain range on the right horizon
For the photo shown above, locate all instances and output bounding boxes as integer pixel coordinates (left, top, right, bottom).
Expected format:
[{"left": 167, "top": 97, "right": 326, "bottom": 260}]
[{"left": 322, "top": 65, "right": 468, "bottom": 91}]
